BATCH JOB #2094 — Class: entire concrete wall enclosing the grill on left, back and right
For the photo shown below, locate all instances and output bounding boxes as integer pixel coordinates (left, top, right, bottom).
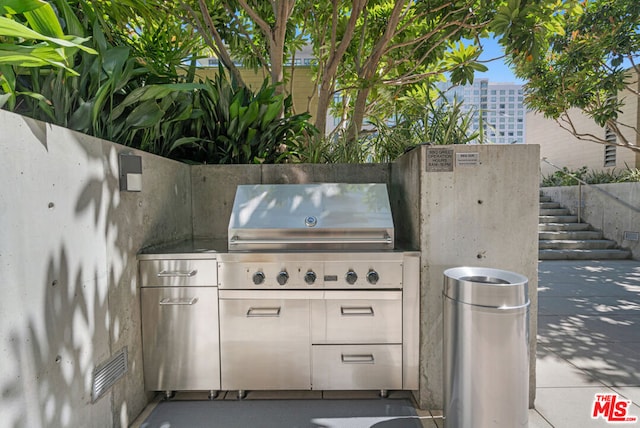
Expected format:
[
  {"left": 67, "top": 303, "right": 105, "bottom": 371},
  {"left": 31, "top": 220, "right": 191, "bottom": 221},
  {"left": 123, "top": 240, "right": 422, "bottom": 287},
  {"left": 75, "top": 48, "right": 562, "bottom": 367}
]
[{"left": 0, "top": 111, "right": 539, "bottom": 427}]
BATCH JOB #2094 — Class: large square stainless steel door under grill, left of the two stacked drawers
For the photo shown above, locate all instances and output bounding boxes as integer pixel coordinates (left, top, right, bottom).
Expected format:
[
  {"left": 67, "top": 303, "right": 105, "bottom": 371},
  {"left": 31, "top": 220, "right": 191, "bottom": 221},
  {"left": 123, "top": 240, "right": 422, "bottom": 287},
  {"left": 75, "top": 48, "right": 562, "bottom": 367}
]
[{"left": 220, "top": 299, "right": 311, "bottom": 390}]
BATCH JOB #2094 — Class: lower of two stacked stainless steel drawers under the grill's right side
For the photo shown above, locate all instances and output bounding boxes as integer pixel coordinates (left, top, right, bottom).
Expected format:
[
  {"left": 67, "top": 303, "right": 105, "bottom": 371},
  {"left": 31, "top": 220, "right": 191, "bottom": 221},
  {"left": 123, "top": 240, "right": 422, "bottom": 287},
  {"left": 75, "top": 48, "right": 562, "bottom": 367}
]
[{"left": 311, "top": 345, "right": 402, "bottom": 390}]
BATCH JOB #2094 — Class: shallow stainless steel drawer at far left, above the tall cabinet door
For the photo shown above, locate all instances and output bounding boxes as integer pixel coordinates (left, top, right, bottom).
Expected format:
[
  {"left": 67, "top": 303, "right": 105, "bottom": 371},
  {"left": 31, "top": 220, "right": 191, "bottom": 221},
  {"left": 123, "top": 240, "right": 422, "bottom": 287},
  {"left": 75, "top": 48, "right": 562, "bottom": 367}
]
[{"left": 140, "top": 259, "right": 218, "bottom": 287}]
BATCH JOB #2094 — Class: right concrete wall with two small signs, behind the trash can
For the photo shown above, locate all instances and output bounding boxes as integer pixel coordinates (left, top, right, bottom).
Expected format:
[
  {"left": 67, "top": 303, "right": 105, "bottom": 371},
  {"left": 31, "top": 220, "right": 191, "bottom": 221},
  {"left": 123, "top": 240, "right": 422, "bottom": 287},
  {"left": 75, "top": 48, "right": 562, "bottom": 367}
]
[{"left": 412, "top": 144, "right": 539, "bottom": 408}]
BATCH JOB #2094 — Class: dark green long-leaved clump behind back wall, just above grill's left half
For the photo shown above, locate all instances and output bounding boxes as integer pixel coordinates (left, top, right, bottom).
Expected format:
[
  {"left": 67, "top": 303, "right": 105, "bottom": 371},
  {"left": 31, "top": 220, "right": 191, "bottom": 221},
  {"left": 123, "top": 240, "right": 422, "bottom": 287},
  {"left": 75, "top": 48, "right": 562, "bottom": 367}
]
[{"left": 172, "top": 69, "right": 317, "bottom": 163}]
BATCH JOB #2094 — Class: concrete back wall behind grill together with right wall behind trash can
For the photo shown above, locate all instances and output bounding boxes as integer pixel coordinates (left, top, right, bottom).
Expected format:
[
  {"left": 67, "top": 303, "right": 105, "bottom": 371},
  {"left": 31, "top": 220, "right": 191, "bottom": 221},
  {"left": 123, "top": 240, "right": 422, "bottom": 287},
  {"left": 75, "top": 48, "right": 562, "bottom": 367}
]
[{"left": 192, "top": 145, "right": 539, "bottom": 409}]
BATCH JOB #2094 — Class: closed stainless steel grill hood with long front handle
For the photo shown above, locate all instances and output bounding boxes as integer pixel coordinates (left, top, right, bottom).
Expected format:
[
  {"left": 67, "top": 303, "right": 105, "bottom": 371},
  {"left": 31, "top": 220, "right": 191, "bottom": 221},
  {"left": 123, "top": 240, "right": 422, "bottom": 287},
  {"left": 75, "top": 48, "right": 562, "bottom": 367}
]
[{"left": 228, "top": 183, "right": 394, "bottom": 251}]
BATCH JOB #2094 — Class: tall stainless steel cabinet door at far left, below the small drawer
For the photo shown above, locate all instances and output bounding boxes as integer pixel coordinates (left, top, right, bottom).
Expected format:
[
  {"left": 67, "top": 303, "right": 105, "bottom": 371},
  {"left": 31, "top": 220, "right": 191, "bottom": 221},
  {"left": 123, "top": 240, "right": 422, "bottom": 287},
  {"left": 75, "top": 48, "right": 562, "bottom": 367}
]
[{"left": 141, "top": 287, "right": 220, "bottom": 391}]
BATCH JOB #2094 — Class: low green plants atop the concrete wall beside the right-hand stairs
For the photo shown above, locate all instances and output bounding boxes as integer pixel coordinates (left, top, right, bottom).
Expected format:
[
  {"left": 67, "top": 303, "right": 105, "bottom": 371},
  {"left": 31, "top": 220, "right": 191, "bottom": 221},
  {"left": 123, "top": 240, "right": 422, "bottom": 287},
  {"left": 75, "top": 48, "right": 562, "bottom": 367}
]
[{"left": 541, "top": 166, "right": 640, "bottom": 187}]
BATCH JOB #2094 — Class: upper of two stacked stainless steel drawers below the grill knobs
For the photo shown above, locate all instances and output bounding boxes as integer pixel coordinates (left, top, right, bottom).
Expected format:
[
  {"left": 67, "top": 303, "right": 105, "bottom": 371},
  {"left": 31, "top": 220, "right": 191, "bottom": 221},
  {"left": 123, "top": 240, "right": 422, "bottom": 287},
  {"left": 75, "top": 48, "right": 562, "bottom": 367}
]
[{"left": 311, "top": 291, "right": 402, "bottom": 344}]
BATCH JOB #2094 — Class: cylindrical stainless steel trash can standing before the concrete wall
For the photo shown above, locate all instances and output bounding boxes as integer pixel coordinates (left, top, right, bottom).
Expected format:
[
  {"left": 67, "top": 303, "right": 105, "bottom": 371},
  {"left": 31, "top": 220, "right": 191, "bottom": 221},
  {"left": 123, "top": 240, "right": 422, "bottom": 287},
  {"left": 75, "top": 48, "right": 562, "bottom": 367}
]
[{"left": 443, "top": 267, "right": 529, "bottom": 428}]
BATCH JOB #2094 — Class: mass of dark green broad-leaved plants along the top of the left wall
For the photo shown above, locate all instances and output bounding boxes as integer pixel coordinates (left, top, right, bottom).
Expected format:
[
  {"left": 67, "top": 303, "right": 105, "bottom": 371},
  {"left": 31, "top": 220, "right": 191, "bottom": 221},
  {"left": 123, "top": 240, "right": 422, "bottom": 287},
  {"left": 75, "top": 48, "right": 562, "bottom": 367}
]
[{"left": 4, "top": 1, "right": 316, "bottom": 163}]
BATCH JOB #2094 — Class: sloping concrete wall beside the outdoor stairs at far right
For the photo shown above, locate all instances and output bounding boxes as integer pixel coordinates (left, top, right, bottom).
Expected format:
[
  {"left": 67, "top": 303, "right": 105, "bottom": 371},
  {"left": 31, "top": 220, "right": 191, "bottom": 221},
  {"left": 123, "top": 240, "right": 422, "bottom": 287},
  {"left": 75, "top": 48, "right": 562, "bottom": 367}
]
[{"left": 541, "top": 183, "right": 640, "bottom": 260}]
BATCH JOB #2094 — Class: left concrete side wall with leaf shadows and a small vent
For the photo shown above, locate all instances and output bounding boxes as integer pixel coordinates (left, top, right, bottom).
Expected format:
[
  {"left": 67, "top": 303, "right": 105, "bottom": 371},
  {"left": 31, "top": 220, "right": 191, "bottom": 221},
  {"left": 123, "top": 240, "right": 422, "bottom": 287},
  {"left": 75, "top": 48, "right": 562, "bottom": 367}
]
[{"left": 0, "top": 110, "right": 191, "bottom": 428}]
